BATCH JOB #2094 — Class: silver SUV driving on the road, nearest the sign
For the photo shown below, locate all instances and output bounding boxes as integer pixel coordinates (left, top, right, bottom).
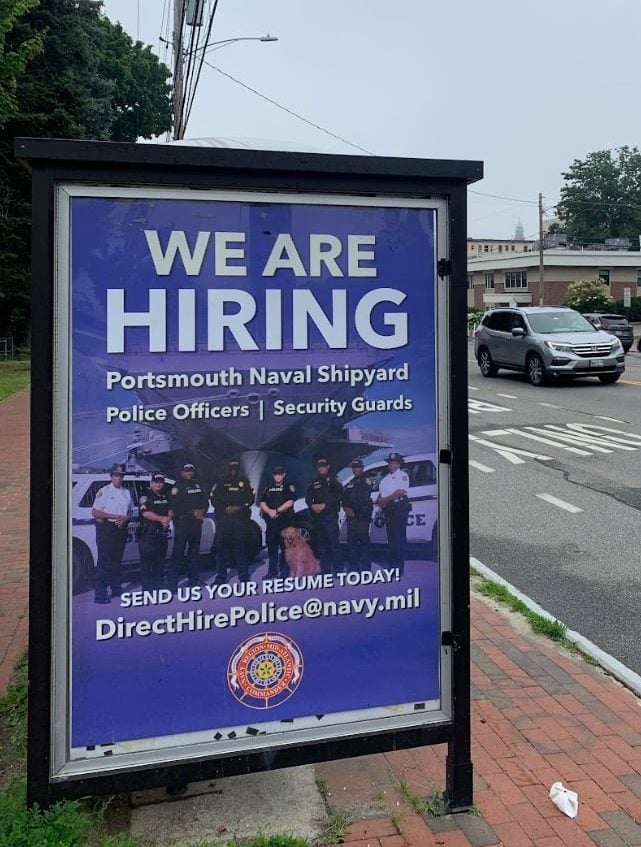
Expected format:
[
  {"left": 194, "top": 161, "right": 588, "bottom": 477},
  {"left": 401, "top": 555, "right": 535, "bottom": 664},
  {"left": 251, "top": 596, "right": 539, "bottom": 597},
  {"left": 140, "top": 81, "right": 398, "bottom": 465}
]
[{"left": 474, "top": 306, "right": 625, "bottom": 385}]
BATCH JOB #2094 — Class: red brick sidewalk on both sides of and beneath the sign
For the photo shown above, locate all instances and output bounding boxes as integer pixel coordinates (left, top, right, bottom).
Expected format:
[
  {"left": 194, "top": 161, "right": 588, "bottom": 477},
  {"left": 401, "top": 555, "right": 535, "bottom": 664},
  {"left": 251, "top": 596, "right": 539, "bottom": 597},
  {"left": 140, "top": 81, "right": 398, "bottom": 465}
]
[{"left": 6, "top": 392, "right": 641, "bottom": 847}]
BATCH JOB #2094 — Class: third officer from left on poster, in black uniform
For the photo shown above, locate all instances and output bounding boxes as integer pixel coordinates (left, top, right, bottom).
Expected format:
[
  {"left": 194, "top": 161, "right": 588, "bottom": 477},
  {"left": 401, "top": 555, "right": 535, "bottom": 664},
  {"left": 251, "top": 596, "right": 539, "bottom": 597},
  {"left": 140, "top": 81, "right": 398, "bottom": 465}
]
[{"left": 167, "top": 462, "right": 208, "bottom": 591}]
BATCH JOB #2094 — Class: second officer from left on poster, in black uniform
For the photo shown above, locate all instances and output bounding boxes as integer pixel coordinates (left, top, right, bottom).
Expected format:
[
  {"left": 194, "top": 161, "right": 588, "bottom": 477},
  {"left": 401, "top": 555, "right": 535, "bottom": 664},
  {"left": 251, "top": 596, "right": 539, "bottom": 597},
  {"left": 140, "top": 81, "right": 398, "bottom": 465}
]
[{"left": 138, "top": 473, "right": 171, "bottom": 591}]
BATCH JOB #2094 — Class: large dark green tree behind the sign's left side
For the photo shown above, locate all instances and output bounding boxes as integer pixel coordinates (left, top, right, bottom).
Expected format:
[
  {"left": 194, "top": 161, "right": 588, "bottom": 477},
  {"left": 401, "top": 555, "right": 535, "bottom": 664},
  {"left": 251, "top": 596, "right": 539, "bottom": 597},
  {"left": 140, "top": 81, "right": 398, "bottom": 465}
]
[{"left": 0, "top": 0, "right": 171, "bottom": 343}]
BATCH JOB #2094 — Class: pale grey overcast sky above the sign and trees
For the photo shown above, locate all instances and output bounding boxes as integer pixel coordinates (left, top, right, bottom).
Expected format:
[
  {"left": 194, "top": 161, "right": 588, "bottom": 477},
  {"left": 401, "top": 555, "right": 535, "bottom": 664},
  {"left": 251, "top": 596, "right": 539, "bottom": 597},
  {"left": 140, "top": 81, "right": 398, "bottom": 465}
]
[{"left": 104, "top": 0, "right": 641, "bottom": 238}]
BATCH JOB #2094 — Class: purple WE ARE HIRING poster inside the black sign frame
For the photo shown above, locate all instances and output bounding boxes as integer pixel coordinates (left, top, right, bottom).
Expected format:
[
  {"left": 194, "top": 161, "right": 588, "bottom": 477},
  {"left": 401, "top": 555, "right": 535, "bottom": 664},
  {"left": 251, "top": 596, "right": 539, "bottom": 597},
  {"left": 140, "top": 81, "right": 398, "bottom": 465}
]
[{"left": 62, "top": 188, "right": 441, "bottom": 761}]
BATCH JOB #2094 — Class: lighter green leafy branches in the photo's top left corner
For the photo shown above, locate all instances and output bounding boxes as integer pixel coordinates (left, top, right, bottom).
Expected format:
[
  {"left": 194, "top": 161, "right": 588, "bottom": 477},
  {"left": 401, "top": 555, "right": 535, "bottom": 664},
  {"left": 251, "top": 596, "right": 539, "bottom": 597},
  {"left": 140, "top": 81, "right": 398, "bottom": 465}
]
[{"left": 0, "top": 0, "right": 42, "bottom": 127}]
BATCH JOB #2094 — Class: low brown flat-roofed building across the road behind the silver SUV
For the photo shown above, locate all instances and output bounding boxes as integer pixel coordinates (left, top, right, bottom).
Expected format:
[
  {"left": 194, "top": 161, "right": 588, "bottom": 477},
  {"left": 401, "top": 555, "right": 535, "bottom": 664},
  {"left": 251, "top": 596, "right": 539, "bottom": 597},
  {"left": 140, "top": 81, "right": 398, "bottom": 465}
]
[{"left": 467, "top": 250, "right": 641, "bottom": 309}]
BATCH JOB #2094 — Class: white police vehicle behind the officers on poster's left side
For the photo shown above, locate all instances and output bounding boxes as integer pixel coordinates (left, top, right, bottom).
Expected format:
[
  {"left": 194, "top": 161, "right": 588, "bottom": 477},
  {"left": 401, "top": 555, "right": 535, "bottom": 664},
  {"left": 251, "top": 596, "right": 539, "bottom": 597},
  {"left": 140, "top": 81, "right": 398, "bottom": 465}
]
[{"left": 71, "top": 471, "right": 215, "bottom": 594}]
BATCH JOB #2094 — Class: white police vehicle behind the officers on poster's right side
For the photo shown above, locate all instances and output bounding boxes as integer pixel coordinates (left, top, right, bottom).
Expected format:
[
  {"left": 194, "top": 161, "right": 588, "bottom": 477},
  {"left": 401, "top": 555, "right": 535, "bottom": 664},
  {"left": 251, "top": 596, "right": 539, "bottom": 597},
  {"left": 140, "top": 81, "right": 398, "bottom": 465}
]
[{"left": 338, "top": 453, "right": 438, "bottom": 558}]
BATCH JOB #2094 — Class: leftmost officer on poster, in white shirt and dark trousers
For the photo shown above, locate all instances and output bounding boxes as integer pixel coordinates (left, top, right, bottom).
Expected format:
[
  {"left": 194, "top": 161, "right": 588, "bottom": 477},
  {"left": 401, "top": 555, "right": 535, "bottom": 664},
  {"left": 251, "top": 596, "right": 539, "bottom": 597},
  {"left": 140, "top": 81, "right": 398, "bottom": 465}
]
[{"left": 91, "top": 464, "right": 132, "bottom": 603}]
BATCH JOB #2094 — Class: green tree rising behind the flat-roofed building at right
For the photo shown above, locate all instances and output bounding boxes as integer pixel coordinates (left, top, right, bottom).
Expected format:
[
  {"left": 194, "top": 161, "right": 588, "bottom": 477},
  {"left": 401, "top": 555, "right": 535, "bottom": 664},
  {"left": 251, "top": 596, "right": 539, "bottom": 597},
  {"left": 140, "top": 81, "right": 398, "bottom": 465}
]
[{"left": 557, "top": 147, "right": 641, "bottom": 248}]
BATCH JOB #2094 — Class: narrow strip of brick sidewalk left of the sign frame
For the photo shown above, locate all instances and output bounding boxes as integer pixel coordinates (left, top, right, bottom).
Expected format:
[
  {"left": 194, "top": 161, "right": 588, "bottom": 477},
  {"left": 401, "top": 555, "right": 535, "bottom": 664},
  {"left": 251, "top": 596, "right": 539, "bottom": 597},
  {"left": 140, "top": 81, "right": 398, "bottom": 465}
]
[{"left": 0, "top": 389, "right": 29, "bottom": 694}]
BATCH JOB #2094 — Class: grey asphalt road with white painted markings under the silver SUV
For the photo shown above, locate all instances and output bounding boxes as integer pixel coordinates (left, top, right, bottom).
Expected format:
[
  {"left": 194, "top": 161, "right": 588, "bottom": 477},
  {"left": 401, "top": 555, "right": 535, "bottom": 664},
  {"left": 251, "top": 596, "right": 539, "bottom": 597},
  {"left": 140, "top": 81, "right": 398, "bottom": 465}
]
[{"left": 469, "top": 347, "right": 641, "bottom": 674}]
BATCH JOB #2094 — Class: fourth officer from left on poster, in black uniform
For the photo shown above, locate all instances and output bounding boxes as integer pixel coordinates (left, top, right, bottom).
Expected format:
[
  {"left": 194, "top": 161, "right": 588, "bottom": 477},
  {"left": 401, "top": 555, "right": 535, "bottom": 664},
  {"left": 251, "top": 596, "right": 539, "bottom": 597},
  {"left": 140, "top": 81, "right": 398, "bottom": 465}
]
[{"left": 209, "top": 459, "right": 254, "bottom": 584}]
